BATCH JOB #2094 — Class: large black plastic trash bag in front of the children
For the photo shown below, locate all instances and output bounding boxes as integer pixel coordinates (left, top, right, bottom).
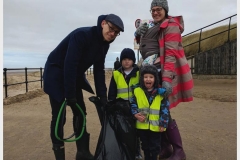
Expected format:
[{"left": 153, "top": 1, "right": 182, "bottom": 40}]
[{"left": 89, "top": 99, "right": 136, "bottom": 160}]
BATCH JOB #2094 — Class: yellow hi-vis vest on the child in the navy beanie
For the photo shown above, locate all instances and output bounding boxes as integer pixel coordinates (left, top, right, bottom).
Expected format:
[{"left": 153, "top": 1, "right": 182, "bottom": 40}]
[{"left": 113, "top": 71, "right": 139, "bottom": 100}]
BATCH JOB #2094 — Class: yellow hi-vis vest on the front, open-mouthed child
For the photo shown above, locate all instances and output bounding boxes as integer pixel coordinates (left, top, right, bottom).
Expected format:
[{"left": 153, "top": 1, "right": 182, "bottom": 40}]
[{"left": 134, "top": 87, "right": 163, "bottom": 132}]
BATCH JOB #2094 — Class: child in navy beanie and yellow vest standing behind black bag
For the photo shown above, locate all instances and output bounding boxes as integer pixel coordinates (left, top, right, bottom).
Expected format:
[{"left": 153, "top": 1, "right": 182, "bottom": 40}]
[{"left": 108, "top": 48, "right": 142, "bottom": 160}]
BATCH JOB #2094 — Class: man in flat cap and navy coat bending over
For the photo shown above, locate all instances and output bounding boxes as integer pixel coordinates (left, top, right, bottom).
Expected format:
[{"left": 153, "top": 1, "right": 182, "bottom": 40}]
[{"left": 43, "top": 14, "right": 124, "bottom": 160}]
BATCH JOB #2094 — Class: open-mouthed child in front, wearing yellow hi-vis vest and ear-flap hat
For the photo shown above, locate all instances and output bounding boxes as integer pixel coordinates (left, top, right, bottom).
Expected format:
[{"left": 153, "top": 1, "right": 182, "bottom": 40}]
[{"left": 130, "top": 65, "right": 169, "bottom": 160}]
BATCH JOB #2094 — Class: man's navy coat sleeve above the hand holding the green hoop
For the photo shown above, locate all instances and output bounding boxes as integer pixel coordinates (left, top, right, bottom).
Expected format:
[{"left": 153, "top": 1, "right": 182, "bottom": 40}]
[{"left": 64, "top": 32, "right": 85, "bottom": 98}]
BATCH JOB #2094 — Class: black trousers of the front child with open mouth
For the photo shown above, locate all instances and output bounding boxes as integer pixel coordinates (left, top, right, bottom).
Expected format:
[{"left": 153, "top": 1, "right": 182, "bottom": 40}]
[{"left": 137, "top": 129, "right": 161, "bottom": 156}]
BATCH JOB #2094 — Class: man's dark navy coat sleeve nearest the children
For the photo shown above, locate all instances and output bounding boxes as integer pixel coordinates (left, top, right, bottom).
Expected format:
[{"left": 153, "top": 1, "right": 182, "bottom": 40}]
[{"left": 93, "top": 48, "right": 108, "bottom": 97}]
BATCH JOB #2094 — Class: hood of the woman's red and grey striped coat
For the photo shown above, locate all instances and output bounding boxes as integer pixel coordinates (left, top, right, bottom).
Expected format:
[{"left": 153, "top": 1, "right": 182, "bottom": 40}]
[{"left": 160, "top": 16, "right": 184, "bottom": 33}]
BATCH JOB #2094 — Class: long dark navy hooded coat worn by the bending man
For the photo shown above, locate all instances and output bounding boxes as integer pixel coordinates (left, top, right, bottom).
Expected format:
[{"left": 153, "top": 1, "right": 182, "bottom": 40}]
[{"left": 43, "top": 15, "right": 113, "bottom": 102}]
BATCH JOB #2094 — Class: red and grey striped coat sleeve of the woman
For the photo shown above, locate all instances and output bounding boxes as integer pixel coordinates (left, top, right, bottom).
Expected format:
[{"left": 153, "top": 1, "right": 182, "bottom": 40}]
[{"left": 162, "top": 23, "right": 181, "bottom": 83}]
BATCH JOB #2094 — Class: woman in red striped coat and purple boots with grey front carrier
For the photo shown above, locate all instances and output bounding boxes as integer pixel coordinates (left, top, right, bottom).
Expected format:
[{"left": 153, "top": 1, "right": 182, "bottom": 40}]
[{"left": 135, "top": 0, "right": 193, "bottom": 160}]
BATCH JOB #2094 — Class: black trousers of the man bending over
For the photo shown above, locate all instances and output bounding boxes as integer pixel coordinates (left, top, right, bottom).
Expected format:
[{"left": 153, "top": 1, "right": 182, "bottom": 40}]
[{"left": 49, "top": 90, "right": 87, "bottom": 145}]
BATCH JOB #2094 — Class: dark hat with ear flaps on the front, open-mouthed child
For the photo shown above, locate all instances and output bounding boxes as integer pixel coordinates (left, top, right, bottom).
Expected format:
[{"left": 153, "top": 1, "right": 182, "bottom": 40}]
[{"left": 140, "top": 65, "right": 159, "bottom": 90}]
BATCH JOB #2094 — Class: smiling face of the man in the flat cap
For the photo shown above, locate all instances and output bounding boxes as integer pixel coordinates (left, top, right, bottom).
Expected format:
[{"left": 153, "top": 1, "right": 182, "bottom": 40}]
[{"left": 101, "top": 20, "right": 120, "bottom": 42}]
